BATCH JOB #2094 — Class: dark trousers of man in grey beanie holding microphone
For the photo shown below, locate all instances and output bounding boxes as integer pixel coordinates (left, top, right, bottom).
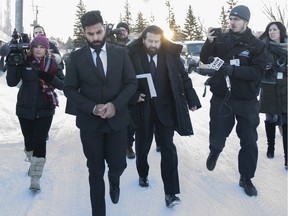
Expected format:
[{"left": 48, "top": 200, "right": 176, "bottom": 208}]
[{"left": 209, "top": 96, "right": 260, "bottom": 179}]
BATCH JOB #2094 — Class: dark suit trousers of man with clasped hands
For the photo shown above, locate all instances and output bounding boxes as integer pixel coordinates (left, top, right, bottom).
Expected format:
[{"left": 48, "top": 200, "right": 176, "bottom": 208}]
[{"left": 80, "top": 121, "right": 127, "bottom": 216}]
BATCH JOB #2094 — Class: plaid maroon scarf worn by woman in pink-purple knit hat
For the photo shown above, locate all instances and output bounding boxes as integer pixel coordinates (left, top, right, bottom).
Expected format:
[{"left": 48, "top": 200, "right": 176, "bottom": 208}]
[{"left": 32, "top": 54, "right": 59, "bottom": 107}]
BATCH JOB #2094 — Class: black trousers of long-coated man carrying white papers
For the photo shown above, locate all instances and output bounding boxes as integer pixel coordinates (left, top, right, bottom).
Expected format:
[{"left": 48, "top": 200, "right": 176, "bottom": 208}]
[{"left": 135, "top": 103, "right": 180, "bottom": 194}]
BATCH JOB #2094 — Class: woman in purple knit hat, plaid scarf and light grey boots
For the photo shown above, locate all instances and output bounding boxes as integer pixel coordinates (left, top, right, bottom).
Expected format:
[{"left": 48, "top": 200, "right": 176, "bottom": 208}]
[{"left": 6, "top": 35, "right": 64, "bottom": 190}]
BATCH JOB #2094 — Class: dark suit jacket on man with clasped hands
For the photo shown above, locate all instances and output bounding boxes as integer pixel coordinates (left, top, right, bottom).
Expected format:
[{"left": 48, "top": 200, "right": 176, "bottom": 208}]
[{"left": 64, "top": 43, "right": 137, "bottom": 130}]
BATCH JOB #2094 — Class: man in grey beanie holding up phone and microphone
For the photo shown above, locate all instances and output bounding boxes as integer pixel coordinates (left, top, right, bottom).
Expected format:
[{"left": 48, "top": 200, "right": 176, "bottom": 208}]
[{"left": 200, "top": 5, "right": 266, "bottom": 196}]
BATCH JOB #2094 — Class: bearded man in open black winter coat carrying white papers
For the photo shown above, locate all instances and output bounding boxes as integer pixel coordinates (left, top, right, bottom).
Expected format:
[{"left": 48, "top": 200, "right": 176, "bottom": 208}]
[{"left": 128, "top": 25, "right": 201, "bottom": 207}]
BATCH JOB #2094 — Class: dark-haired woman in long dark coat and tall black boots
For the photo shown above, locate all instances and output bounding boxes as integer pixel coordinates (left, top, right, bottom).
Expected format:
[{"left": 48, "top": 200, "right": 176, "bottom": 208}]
[{"left": 259, "top": 22, "right": 287, "bottom": 169}]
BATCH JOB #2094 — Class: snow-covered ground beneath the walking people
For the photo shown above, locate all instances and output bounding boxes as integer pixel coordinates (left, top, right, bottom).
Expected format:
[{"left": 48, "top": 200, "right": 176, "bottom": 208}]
[{"left": 0, "top": 72, "right": 287, "bottom": 216}]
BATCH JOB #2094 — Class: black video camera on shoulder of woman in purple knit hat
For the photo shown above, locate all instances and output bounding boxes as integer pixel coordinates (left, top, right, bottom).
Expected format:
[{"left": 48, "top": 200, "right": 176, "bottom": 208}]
[{"left": 1, "top": 29, "right": 30, "bottom": 65}]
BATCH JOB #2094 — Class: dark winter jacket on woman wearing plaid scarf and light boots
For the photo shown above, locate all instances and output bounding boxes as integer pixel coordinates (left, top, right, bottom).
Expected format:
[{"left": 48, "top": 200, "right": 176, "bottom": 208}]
[{"left": 6, "top": 61, "right": 64, "bottom": 120}]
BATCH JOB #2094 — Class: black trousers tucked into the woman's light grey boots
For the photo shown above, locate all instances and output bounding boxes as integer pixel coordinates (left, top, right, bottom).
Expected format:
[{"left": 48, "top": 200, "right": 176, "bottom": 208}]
[{"left": 18, "top": 116, "right": 53, "bottom": 158}]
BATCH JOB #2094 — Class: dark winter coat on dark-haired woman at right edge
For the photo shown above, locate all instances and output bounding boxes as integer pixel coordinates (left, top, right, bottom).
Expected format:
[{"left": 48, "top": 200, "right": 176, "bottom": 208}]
[{"left": 260, "top": 38, "right": 287, "bottom": 115}]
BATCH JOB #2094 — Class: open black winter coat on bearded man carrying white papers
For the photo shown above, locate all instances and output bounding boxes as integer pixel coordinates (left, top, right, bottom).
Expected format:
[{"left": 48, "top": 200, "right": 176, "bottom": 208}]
[{"left": 128, "top": 38, "right": 201, "bottom": 136}]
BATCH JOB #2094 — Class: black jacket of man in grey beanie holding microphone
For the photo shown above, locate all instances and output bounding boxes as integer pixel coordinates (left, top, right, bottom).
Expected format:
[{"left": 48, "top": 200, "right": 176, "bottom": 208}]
[{"left": 200, "top": 28, "right": 266, "bottom": 100}]
